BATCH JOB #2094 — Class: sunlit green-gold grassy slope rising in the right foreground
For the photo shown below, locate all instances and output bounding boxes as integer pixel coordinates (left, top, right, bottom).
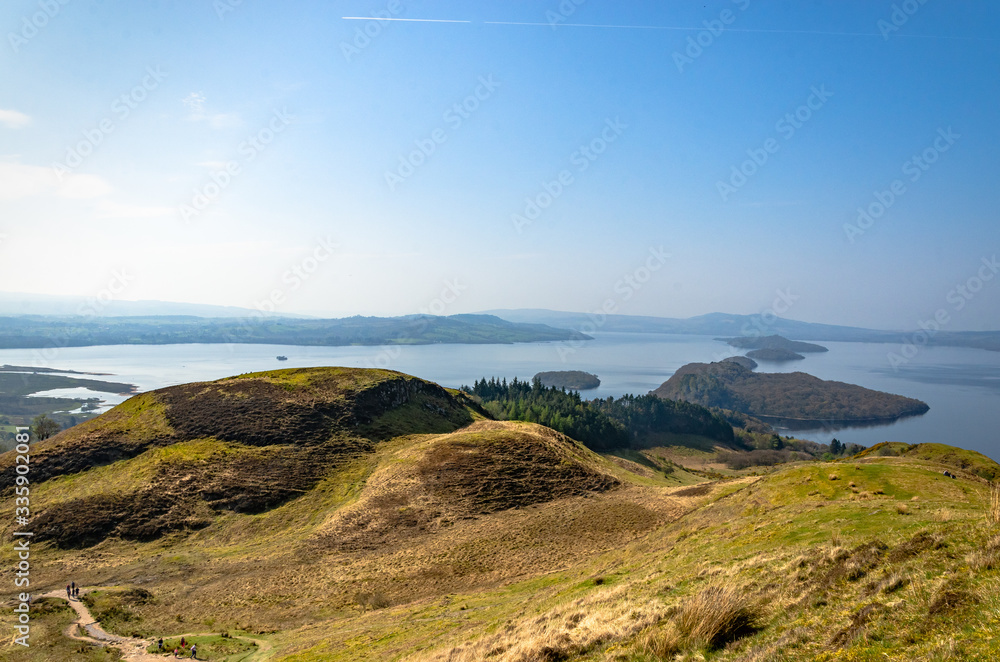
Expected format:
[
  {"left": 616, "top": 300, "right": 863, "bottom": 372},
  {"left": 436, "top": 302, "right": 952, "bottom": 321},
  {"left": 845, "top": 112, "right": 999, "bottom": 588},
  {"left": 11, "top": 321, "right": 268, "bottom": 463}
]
[{"left": 268, "top": 459, "right": 1000, "bottom": 662}]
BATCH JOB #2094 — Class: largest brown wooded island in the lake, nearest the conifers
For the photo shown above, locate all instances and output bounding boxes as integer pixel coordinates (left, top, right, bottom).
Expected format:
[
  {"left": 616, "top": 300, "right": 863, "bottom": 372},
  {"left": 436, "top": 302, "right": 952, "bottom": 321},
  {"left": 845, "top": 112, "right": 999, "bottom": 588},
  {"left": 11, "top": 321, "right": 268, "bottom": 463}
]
[{"left": 653, "top": 361, "right": 929, "bottom": 423}]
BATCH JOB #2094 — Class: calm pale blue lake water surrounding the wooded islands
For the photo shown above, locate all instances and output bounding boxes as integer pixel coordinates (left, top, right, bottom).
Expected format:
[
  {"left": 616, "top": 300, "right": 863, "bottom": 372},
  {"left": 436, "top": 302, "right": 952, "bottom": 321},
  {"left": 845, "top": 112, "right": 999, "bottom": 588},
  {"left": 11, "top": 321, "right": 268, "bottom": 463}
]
[{"left": 0, "top": 333, "right": 1000, "bottom": 459}]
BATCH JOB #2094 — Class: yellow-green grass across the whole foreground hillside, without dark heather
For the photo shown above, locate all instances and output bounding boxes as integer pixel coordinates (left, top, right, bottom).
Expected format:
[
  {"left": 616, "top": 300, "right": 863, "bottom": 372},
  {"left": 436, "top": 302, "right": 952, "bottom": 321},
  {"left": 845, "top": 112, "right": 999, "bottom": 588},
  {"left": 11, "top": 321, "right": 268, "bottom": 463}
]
[{"left": 0, "top": 373, "right": 1000, "bottom": 662}]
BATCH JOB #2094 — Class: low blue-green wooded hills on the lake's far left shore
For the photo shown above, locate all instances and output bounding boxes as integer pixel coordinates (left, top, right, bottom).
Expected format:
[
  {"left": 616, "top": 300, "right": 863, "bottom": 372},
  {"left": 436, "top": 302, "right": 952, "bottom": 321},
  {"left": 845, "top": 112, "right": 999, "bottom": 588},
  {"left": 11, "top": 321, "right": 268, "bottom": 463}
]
[{"left": 0, "top": 315, "right": 590, "bottom": 348}]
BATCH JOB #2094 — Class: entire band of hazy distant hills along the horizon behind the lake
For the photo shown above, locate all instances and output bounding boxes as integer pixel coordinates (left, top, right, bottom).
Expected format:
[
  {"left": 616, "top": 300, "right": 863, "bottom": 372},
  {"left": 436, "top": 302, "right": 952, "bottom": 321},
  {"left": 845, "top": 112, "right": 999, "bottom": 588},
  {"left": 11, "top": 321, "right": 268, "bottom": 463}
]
[{"left": 0, "top": 292, "right": 1000, "bottom": 351}]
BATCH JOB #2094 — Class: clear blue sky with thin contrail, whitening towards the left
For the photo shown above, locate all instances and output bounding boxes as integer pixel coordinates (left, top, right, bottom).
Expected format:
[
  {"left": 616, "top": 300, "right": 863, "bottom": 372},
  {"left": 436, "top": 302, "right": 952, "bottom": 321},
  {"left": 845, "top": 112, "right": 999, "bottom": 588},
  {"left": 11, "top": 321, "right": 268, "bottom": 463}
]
[{"left": 0, "top": 0, "right": 1000, "bottom": 330}]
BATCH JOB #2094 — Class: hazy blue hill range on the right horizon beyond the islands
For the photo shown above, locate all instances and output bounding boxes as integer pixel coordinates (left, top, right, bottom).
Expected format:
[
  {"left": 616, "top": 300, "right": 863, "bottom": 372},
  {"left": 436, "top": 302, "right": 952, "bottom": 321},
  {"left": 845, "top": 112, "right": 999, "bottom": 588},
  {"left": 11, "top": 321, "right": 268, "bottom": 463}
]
[{"left": 484, "top": 308, "right": 1000, "bottom": 351}]
